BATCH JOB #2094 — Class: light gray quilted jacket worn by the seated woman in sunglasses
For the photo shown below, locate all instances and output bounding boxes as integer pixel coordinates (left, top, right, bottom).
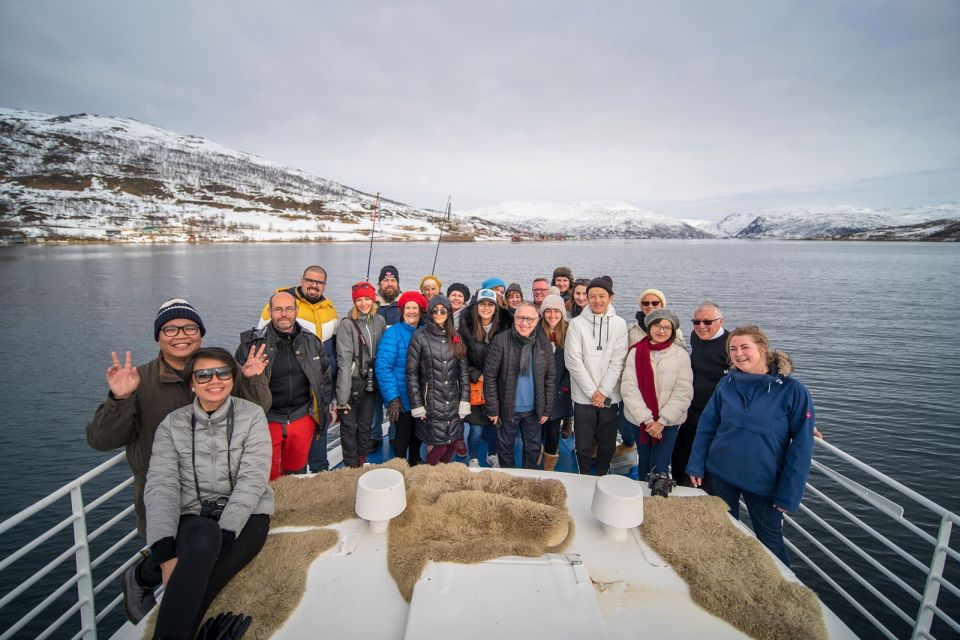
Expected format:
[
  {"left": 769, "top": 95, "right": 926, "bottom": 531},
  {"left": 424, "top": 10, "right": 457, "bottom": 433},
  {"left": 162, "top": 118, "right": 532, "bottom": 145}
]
[{"left": 144, "top": 398, "right": 273, "bottom": 561}]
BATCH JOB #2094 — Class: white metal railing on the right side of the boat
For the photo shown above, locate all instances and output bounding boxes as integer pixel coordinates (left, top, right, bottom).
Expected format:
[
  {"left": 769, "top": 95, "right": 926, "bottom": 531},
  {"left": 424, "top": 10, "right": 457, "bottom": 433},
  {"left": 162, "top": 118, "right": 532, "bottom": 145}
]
[{"left": 784, "top": 439, "right": 960, "bottom": 639}]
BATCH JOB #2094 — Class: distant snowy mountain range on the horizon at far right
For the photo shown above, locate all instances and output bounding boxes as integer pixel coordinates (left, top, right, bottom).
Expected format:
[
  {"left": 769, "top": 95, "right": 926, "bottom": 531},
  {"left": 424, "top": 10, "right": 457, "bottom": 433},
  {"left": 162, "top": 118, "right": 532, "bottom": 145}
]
[{"left": 707, "top": 203, "right": 960, "bottom": 240}]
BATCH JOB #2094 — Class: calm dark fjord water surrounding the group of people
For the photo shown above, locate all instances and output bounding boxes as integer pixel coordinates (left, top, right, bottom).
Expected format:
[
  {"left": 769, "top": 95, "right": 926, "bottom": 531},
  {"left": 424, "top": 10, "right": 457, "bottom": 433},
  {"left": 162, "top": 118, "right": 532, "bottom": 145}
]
[{"left": 0, "top": 240, "right": 960, "bottom": 636}]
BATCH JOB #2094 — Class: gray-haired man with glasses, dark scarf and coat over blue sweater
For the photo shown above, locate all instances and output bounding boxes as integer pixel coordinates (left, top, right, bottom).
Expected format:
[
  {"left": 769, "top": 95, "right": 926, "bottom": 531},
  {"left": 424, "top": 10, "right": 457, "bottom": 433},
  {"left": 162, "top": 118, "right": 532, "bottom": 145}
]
[{"left": 483, "top": 302, "right": 556, "bottom": 469}]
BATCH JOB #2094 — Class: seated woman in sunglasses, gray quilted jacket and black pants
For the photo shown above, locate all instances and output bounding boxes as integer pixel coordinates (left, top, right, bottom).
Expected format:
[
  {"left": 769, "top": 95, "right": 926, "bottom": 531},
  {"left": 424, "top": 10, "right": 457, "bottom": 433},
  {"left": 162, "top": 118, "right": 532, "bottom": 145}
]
[{"left": 138, "top": 348, "right": 273, "bottom": 639}]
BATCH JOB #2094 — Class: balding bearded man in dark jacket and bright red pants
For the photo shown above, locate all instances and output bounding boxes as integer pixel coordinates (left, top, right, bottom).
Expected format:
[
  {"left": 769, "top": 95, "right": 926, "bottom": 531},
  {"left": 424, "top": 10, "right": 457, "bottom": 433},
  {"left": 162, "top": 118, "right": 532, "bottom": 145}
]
[{"left": 237, "top": 291, "right": 333, "bottom": 480}]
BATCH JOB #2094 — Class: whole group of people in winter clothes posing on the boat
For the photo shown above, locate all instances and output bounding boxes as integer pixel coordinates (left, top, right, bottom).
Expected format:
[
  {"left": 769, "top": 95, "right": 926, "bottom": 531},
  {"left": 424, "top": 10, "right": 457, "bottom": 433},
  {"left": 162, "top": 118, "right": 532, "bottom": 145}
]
[{"left": 87, "top": 265, "right": 814, "bottom": 638}]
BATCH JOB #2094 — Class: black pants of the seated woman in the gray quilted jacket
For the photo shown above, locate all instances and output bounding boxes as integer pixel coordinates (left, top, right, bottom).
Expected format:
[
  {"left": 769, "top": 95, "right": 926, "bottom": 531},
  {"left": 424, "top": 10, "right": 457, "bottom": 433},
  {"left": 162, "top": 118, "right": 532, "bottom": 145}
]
[{"left": 153, "top": 514, "right": 270, "bottom": 640}]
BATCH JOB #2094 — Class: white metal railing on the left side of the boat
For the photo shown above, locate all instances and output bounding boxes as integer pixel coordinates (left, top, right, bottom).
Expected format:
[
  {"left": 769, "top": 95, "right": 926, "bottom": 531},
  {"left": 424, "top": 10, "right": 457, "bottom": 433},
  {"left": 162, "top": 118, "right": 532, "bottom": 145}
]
[{"left": 0, "top": 453, "right": 140, "bottom": 640}]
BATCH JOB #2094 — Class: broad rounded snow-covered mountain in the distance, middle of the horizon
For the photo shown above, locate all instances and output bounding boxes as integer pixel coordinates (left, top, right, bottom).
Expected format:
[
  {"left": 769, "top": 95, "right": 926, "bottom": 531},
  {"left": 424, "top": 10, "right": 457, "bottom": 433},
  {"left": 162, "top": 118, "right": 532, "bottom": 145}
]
[{"left": 459, "top": 200, "right": 713, "bottom": 238}]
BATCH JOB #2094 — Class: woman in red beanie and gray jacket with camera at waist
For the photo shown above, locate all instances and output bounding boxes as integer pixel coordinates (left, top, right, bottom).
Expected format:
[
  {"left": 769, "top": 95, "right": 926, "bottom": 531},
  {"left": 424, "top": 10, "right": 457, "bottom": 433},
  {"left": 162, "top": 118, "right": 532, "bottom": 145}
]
[{"left": 337, "top": 282, "right": 387, "bottom": 467}]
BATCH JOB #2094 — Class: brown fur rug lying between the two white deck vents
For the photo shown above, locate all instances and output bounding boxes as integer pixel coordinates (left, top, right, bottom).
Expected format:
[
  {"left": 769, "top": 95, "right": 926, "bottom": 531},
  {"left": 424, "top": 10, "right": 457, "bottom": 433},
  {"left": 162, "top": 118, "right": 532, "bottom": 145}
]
[{"left": 387, "top": 464, "right": 574, "bottom": 602}]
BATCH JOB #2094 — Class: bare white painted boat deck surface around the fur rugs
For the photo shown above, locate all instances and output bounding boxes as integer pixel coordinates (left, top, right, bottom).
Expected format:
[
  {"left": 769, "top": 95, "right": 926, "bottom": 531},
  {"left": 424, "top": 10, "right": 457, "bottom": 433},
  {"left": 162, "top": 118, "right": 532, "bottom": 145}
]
[{"left": 115, "top": 470, "right": 856, "bottom": 640}]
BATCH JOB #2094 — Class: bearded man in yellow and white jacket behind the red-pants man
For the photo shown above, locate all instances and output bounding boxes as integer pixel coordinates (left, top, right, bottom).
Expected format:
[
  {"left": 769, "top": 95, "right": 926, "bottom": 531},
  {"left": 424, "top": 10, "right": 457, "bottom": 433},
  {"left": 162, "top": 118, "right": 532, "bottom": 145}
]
[{"left": 256, "top": 265, "right": 337, "bottom": 473}]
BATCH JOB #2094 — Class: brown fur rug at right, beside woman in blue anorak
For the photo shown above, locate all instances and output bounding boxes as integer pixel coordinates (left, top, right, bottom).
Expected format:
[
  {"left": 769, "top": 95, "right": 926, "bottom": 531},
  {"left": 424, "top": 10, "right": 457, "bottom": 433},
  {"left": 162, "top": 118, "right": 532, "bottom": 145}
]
[{"left": 640, "top": 496, "right": 827, "bottom": 640}]
